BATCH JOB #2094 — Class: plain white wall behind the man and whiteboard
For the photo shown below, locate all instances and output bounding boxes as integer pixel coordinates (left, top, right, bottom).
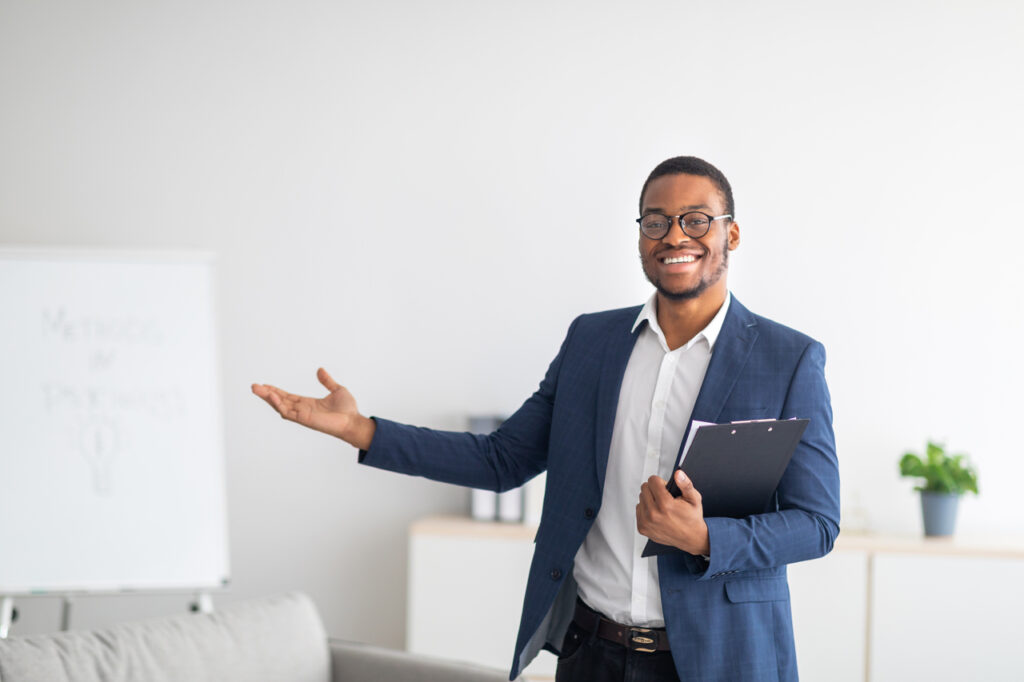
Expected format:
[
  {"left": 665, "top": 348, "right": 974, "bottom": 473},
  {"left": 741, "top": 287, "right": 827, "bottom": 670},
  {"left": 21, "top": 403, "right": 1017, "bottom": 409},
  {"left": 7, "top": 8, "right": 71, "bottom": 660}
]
[{"left": 0, "top": 0, "right": 1024, "bottom": 651}]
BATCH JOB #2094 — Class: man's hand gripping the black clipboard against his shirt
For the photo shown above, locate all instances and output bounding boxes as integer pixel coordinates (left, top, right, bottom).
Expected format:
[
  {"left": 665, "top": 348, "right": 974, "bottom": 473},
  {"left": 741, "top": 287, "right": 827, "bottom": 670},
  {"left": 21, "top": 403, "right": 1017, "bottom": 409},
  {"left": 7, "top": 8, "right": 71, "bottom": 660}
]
[{"left": 637, "top": 469, "right": 711, "bottom": 555}]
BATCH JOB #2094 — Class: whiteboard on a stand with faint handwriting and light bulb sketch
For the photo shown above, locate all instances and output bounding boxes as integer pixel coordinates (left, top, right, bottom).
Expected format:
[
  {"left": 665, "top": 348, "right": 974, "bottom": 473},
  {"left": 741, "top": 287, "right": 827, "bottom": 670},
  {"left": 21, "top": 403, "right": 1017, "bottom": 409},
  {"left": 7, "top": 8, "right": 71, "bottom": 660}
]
[{"left": 0, "top": 249, "right": 228, "bottom": 594}]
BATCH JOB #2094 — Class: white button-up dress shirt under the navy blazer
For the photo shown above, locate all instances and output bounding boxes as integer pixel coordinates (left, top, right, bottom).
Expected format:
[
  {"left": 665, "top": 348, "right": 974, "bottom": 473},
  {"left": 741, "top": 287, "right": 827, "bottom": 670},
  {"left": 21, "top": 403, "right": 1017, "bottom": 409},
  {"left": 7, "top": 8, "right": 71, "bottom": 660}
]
[{"left": 572, "top": 294, "right": 732, "bottom": 628}]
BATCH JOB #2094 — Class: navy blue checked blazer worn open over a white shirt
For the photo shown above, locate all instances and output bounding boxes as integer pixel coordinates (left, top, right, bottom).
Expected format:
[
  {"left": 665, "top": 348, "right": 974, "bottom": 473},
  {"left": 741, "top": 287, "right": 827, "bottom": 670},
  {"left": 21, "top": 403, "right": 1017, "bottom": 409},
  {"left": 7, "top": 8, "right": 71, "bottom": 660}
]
[{"left": 360, "top": 297, "right": 840, "bottom": 682}]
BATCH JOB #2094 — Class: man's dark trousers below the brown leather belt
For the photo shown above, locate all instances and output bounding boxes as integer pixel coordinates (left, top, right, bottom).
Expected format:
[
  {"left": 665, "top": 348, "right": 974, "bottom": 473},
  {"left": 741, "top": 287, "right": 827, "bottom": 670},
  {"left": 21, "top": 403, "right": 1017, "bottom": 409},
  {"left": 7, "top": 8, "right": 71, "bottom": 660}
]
[{"left": 555, "top": 606, "right": 679, "bottom": 682}]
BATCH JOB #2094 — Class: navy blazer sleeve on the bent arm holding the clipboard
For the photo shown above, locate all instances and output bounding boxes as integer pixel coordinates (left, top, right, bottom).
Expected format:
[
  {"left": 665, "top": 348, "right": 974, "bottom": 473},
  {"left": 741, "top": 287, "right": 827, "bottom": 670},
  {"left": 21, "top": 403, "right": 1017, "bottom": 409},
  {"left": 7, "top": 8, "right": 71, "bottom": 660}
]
[{"left": 700, "top": 341, "right": 840, "bottom": 580}]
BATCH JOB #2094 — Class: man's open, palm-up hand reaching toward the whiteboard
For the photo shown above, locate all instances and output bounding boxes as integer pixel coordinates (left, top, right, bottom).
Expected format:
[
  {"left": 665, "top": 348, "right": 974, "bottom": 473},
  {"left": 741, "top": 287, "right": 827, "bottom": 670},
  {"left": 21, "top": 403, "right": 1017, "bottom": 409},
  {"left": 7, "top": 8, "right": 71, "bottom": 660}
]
[{"left": 252, "top": 368, "right": 376, "bottom": 450}]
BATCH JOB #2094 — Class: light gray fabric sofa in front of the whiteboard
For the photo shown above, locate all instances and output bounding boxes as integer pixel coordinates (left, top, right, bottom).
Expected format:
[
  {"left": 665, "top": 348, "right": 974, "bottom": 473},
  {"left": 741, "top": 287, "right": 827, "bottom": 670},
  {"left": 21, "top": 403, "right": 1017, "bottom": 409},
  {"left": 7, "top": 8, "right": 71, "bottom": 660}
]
[{"left": 0, "top": 593, "right": 507, "bottom": 682}]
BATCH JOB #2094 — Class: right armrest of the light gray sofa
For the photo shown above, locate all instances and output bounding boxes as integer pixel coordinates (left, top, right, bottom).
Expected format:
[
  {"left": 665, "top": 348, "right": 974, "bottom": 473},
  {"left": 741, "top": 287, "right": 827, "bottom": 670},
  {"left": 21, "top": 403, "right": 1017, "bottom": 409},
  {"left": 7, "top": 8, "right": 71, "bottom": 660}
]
[{"left": 329, "top": 639, "right": 508, "bottom": 682}]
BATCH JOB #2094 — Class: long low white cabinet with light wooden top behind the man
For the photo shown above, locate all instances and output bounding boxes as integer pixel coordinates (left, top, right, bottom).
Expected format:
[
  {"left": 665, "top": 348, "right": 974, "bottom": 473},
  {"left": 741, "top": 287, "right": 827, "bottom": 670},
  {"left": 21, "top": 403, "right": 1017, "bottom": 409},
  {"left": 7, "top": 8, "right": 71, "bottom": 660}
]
[{"left": 407, "top": 517, "right": 1024, "bottom": 682}]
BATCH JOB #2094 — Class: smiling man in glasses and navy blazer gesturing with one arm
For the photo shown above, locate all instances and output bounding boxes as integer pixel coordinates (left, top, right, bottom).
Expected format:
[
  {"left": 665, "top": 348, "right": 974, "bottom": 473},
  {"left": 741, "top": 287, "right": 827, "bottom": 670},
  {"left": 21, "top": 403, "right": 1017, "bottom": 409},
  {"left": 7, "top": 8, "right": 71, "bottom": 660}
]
[{"left": 253, "top": 157, "right": 839, "bottom": 682}]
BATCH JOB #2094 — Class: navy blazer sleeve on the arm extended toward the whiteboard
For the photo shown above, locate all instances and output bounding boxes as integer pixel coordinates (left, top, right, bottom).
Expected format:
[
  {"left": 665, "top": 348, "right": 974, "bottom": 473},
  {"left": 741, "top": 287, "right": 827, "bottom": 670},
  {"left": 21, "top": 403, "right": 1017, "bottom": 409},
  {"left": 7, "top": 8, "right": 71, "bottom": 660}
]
[{"left": 359, "top": 318, "right": 579, "bottom": 493}]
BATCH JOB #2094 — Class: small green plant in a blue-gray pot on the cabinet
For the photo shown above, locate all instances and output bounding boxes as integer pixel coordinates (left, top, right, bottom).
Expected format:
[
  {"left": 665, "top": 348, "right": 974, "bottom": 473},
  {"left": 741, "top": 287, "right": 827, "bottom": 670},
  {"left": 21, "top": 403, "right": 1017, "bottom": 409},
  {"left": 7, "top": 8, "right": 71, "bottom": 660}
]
[{"left": 899, "top": 440, "right": 978, "bottom": 536}]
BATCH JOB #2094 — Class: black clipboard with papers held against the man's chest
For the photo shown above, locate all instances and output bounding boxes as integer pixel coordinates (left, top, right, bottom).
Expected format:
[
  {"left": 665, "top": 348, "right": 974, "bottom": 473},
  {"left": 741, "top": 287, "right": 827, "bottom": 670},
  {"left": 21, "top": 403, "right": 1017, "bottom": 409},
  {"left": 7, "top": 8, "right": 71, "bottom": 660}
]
[{"left": 641, "top": 419, "right": 810, "bottom": 556}]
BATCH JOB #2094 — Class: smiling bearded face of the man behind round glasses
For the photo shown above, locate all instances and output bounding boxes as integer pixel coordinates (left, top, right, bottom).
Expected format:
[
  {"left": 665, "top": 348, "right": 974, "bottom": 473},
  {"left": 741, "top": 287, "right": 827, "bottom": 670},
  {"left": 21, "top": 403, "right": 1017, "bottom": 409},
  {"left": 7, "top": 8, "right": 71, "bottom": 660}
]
[{"left": 640, "top": 174, "right": 739, "bottom": 300}]
